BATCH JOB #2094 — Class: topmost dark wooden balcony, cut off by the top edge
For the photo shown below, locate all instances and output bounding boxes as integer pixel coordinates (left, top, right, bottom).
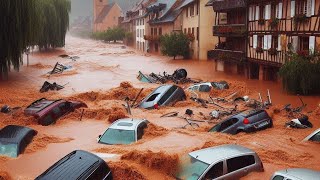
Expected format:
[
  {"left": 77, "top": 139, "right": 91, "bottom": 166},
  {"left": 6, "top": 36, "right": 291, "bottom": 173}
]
[{"left": 210, "top": 0, "right": 246, "bottom": 12}]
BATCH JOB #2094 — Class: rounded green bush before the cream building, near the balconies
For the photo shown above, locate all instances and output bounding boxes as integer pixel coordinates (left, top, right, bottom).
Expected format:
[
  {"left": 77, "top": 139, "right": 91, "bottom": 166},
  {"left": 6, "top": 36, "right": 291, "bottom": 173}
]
[{"left": 160, "top": 32, "right": 190, "bottom": 59}]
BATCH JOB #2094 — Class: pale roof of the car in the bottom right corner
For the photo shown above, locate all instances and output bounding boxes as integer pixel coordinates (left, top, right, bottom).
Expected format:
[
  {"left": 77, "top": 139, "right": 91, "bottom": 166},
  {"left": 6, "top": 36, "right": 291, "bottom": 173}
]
[{"left": 275, "top": 168, "right": 320, "bottom": 179}]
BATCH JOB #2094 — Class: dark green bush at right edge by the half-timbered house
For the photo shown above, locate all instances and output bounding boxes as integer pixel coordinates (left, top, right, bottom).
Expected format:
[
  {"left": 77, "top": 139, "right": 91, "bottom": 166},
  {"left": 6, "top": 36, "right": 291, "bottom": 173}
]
[{"left": 279, "top": 52, "right": 320, "bottom": 95}]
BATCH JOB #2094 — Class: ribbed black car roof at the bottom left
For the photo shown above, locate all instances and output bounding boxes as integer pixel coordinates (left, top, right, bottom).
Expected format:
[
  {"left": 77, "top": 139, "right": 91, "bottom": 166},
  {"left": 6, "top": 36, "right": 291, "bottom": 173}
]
[{"left": 36, "top": 150, "right": 105, "bottom": 180}]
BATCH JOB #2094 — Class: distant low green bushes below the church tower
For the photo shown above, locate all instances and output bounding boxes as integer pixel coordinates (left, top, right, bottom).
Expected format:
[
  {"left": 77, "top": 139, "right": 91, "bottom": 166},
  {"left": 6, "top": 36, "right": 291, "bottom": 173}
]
[{"left": 92, "top": 27, "right": 125, "bottom": 42}]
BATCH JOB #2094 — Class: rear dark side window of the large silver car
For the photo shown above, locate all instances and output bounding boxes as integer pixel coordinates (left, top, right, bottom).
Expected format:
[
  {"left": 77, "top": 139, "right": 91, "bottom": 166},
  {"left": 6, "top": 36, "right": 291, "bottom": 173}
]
[{"left": 227, "top": 155, "right": 255, "bottom": 173}]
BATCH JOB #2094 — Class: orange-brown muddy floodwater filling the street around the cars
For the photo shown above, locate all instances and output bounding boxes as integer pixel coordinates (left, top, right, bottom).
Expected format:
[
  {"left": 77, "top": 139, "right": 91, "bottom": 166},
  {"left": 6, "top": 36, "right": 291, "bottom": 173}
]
[{"left": 0, "top": 36, "right": 320, "bottom": 179}]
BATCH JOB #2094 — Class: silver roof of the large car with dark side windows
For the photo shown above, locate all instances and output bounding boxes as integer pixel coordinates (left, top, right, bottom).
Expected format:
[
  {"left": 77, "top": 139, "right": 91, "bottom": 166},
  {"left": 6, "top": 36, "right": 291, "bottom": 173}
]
[{"left": 189, "top": 144, "right": 255, "bottom": 164}]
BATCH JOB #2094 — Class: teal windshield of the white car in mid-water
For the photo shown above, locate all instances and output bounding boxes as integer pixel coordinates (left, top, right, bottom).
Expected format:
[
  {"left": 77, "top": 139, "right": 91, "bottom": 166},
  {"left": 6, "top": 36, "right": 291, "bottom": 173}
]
[{"left": 99, "top": 128, "right": 136, "bottom": 144}]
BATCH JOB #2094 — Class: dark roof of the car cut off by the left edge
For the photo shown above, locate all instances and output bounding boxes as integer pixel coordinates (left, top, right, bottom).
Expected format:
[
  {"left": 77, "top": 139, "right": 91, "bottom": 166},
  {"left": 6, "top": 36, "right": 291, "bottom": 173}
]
[{"left": 0, "top": 125, "right": 36, "bottom": 144}]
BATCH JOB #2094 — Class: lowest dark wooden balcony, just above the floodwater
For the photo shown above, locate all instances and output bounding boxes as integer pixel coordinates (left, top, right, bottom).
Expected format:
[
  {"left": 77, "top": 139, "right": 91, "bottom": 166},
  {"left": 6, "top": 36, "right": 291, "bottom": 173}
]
[{"left": 208, "top": 49, "right": 246, "bottom": 63}]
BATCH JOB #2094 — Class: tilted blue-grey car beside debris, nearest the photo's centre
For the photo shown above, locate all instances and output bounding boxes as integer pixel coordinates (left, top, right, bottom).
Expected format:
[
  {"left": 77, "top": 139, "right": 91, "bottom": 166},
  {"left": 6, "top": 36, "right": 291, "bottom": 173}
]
[{"left": 139, "top": 85, "right": 186, "bottom": 109}]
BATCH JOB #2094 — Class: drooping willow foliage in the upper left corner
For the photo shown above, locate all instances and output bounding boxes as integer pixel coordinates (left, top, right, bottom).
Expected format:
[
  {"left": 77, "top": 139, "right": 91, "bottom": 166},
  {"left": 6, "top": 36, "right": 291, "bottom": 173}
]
[{"left": 0, "top": 0, "right": 71, "bottom": 79}]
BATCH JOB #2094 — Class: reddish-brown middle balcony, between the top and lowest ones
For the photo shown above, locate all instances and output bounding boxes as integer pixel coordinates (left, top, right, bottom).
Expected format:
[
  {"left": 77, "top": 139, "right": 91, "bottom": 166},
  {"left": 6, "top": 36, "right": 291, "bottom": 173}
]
[{"left": 212, "top": 24, "right": 247, "bottom": 37}]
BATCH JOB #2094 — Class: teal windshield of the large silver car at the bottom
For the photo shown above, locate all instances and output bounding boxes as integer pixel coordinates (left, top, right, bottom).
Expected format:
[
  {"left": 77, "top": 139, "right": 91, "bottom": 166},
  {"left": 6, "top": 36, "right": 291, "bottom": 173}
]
[{"left": 176, "top": 155, "right": 209, "bottom": 180}]
